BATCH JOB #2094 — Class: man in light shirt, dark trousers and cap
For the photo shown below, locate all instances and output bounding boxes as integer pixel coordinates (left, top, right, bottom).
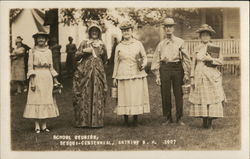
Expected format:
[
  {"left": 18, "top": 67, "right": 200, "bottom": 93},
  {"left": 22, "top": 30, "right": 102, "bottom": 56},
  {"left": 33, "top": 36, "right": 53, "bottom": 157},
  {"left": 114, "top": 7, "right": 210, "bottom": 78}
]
[{"left": 151, "top": 18, "right": 190, "bottom": 126}]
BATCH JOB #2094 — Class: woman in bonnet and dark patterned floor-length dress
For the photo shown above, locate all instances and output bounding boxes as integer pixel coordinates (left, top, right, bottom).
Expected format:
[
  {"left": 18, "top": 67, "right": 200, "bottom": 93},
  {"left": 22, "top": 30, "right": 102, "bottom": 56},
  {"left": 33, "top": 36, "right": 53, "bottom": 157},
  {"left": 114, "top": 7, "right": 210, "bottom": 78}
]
[{"left": 73, "top": 23, "right": 107, "bottom": 127}]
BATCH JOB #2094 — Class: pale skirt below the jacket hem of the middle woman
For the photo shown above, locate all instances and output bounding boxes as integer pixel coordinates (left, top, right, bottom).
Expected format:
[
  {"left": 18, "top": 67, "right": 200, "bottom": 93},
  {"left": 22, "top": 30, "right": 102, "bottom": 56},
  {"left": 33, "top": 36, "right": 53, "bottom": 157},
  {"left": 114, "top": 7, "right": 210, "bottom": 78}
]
[{"left": 115, "top": 77, "right": 150, "bottom": 115}]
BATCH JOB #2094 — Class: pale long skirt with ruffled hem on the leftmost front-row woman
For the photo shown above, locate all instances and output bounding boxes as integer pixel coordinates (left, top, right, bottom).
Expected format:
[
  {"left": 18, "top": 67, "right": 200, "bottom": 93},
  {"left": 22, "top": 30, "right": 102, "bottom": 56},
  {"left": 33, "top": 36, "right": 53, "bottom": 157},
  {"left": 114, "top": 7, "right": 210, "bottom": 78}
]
[{"left": 23, "top": 68, "right": 59, "bottom": 119}]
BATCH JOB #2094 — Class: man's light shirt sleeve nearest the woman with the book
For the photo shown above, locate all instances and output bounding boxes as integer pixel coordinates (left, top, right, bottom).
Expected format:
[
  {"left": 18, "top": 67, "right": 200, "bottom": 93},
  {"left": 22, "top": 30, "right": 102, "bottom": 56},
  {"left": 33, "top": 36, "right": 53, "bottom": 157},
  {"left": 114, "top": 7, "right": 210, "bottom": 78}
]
[{"left": 180, "top": 41, "right": 191, "bottom": 76}]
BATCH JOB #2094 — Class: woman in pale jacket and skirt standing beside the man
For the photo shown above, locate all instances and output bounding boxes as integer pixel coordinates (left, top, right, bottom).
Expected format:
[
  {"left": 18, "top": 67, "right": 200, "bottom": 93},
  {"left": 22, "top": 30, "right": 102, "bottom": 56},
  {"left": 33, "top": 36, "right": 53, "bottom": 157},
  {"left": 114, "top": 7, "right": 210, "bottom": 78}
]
[{"left": 113, "top": 21, "right": 150, "bottom": 126}]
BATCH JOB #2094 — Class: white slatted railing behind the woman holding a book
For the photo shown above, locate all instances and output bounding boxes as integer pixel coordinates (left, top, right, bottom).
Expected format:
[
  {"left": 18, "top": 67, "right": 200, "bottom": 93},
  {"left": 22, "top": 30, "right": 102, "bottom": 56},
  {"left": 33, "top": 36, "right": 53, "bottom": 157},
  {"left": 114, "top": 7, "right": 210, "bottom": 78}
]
[{"left": 185, "top": 39, "right": 240, "bottom": 75}]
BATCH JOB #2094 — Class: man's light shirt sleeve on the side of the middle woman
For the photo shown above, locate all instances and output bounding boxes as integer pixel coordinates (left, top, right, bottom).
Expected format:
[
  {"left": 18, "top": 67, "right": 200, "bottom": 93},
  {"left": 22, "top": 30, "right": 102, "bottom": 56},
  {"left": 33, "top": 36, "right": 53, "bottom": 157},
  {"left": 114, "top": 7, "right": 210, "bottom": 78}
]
[{"left": 151, "top": 43, "right": 161, "bottom": 77}]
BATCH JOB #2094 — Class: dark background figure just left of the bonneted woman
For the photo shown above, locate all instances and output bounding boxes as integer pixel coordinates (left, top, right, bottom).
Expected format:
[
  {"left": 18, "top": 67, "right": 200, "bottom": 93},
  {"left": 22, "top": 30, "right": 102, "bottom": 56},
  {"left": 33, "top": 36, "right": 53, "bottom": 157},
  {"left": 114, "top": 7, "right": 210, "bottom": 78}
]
[{"left": 66, "top": 36, "right": 77, "bottom": 76}]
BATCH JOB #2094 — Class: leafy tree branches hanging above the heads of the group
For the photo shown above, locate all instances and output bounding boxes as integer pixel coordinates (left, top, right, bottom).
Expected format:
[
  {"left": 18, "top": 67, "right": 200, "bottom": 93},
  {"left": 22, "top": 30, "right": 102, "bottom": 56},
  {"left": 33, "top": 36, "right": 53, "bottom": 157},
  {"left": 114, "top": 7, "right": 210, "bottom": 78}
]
[{"left": 60, "top": 8, "right": 198, "bottom": 26}]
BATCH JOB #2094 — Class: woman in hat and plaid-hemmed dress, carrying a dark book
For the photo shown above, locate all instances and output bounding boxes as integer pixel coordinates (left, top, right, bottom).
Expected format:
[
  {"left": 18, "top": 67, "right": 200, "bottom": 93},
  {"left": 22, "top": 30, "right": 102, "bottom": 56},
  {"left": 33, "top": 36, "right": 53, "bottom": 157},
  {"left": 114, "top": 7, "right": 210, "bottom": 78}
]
[{"left": 189, "top": 24, "right": 226, "bottom": 128}]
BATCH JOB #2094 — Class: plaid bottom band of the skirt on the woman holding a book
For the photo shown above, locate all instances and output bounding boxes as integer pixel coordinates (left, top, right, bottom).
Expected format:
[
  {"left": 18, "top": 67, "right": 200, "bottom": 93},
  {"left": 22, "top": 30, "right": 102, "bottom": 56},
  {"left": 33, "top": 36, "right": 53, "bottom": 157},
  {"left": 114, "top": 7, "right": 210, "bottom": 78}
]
[{"left": 189, "top": 103, "right": 223, "bottom": 118}]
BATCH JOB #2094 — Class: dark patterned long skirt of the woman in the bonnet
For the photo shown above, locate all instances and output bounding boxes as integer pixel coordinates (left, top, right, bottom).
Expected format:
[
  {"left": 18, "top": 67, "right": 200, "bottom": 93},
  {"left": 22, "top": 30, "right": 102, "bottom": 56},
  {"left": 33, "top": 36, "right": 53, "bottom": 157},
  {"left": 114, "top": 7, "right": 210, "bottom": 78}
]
[{"left": 73, "top": 56, "right": 107, "bottom": 127}]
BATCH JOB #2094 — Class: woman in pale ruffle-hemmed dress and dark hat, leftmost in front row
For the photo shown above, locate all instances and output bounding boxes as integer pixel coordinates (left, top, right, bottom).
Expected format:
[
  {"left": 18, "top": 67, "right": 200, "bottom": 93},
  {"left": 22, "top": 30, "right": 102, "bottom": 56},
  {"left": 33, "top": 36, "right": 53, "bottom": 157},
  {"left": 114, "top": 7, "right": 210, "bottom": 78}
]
[{"left": 23, "top": 32, "right": 59, "bottom": 133}]
